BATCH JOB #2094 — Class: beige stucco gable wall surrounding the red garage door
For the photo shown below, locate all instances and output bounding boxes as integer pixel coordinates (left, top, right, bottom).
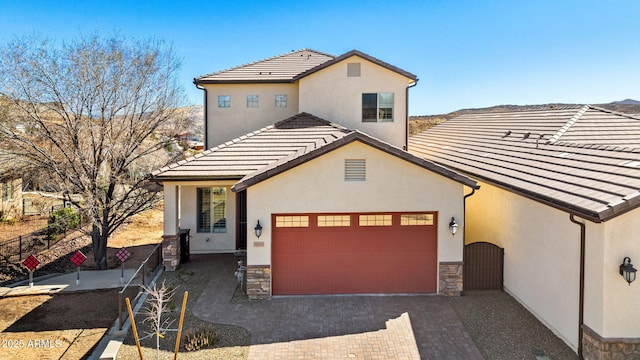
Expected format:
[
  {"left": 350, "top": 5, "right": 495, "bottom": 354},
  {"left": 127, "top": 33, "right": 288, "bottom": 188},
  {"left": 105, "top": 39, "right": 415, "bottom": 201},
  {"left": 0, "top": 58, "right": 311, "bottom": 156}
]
[{"left": 247, "top": 142, "right": 464, "bottom": 276}]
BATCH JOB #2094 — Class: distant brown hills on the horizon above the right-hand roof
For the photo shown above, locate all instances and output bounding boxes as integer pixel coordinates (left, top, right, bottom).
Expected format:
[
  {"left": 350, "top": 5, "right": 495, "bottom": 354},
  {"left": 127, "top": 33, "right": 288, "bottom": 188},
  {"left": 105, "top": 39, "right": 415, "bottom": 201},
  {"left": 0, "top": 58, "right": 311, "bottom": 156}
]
[{"left": 409, "top": 99, "right": 640, "bottom": 135}]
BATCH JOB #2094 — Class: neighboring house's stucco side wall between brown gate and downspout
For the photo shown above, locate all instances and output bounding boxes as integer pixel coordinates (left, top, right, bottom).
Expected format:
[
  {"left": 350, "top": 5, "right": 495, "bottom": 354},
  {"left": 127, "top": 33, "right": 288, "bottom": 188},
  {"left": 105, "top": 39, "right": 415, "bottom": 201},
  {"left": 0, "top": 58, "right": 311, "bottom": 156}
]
[{"left": 466, "top": 184, "right": 580, "bottom": 349}]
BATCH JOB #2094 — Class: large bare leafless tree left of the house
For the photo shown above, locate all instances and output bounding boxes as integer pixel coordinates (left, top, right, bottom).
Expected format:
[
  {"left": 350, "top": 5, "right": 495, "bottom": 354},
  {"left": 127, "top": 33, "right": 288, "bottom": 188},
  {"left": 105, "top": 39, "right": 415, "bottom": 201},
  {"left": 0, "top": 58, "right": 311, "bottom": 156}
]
[{"left": 0, "top": 34, "right": 184, "bottom": 269}]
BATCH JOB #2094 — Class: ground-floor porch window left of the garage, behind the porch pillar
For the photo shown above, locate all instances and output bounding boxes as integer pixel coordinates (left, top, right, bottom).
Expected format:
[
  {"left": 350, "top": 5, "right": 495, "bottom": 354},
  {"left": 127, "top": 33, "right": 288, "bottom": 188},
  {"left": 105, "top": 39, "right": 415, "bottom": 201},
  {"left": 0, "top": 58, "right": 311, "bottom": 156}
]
[{"left": 197, "top": 187, "right": 227, "bottom": 233}]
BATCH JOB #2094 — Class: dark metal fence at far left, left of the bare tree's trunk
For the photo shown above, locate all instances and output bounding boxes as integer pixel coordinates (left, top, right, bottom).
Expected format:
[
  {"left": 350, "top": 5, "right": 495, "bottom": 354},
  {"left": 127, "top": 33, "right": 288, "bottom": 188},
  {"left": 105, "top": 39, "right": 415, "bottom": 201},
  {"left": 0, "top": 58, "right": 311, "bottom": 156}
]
[{"left": 0, "top": 211, "right": 87, "bottom": 266}]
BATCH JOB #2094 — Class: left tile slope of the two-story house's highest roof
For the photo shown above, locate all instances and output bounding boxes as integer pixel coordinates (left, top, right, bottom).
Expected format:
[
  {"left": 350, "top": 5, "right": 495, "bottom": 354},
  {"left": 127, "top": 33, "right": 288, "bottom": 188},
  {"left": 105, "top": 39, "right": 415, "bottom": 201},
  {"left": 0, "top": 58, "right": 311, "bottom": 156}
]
[{"left": 193, "top": 49, "right": 334, "bottom": 84}]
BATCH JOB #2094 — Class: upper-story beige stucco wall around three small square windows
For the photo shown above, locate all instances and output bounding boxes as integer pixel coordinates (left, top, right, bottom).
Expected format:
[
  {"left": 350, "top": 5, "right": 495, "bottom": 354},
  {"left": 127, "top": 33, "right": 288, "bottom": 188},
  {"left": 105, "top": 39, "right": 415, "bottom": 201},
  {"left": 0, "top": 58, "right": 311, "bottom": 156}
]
[{"left": 204, "top": 83, "right": 300, "bottom": 147}]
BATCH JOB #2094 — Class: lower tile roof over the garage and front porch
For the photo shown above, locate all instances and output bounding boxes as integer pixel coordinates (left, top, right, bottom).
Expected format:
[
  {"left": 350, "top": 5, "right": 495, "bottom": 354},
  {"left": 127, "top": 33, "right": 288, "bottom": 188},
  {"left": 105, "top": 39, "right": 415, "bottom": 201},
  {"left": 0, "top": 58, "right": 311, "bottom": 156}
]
[{"left": 152, "top": 113, "right": 477, "bottom": 191}]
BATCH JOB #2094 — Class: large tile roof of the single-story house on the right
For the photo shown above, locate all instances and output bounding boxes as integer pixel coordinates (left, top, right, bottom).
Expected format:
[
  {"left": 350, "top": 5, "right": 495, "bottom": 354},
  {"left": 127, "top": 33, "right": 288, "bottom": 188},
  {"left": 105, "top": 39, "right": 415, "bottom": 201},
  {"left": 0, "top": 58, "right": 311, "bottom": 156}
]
[{"left": 409, "top": 106, "right": 640, "bottom": 222}]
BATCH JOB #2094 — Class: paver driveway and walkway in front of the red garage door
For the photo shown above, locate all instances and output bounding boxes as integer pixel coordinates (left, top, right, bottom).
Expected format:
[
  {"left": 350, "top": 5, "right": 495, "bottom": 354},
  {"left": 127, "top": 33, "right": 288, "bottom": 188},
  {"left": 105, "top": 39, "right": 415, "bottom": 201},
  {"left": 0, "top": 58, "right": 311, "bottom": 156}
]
[{"left": 193, "top": 255, "right": 482, "bottom": 360}]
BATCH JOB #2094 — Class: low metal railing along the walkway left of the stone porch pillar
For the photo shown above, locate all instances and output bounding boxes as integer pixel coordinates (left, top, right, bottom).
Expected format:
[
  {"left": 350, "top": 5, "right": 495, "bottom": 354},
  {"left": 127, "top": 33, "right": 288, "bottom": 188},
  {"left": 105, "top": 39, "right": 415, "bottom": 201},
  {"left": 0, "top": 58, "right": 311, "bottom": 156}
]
[{"left": 118, "top": 243, "right": 162, "bottom": 330}]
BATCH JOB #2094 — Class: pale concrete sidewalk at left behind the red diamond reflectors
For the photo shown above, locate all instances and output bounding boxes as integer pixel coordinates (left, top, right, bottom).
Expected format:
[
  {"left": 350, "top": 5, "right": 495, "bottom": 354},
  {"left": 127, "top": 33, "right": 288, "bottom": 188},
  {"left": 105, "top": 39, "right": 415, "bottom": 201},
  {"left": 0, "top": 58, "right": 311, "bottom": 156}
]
[{"left": 0, "top": 269, "right": 142, "bottom": 297}]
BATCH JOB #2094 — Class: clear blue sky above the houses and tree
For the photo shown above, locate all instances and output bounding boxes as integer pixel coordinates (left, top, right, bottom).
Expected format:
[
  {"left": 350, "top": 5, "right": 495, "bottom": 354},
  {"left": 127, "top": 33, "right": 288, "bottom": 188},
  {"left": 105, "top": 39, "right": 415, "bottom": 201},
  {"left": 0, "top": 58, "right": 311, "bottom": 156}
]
[{"left": 0, "top": 0, "right": 640, "bottom": 115}]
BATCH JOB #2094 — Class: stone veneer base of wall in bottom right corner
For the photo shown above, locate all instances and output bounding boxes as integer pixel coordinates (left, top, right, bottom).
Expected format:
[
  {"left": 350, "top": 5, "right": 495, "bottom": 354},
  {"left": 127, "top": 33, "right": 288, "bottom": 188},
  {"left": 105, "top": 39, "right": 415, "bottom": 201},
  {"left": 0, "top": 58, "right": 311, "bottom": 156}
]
[{"left": 582, "top": 325, "right": 640, "bottom": 360}]
